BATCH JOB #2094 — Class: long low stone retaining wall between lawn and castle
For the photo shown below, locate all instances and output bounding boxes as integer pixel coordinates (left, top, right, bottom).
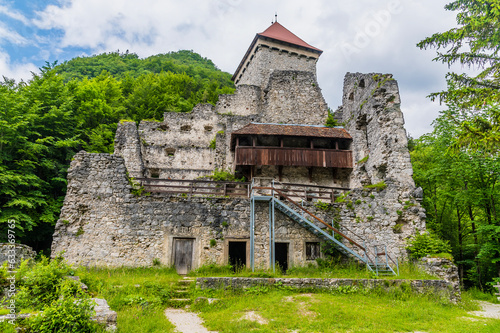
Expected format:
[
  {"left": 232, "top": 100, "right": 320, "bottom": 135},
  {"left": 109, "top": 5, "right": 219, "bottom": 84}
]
[{"left": 196, "top": 277, "right": 456, "bottom": 302}]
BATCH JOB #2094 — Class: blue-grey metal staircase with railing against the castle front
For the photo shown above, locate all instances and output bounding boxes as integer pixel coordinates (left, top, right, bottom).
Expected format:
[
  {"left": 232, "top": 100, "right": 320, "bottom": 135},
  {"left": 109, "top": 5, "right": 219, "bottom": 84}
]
[{"left": 250, "top": 182, "right": 399, "bottom": 275}]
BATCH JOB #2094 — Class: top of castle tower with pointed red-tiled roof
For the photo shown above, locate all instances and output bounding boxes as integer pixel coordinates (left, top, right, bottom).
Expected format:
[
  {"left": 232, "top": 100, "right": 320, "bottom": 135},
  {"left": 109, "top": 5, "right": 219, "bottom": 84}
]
[{"left": 233, "top": 22, "right": 323, "bottom": 89}]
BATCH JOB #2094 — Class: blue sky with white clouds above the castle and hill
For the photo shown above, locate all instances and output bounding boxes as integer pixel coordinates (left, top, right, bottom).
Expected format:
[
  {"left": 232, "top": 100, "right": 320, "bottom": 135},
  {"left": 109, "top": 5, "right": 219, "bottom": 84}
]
[{"left": 0, "top": 0, "right": 462, "bottom": 137}]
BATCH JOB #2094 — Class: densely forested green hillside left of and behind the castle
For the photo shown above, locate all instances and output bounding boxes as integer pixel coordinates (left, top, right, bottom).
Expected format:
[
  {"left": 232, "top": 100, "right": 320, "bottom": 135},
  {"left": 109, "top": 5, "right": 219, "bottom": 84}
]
[{"left": 0, "top": 51, "right": 234, "bottom": 250}]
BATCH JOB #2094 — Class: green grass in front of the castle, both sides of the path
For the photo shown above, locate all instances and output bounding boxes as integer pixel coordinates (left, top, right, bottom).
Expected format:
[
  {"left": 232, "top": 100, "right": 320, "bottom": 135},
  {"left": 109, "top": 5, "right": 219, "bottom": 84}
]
[{"left": 71, "top": 266, "right": 500, "bottom": 333}]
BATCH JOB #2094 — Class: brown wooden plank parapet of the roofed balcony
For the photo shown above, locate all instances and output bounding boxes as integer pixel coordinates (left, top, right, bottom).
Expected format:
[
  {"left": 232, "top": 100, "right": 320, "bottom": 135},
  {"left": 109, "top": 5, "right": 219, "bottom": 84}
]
[{"left": 235, "top": 146, "right": 353, "bottom": 169}]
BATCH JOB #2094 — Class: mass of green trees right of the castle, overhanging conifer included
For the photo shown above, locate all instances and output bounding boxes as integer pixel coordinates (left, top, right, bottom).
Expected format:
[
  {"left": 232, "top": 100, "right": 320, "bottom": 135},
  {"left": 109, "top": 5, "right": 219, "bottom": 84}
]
[{"left": 412, "top": 0, "right": 500, "bottom": 287}]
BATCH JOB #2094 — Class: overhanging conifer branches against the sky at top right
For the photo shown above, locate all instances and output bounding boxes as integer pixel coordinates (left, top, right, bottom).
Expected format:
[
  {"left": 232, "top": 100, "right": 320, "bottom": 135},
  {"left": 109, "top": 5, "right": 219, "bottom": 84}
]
[{"left": 417, "top": 0, "right": 500, "bottom": 153}]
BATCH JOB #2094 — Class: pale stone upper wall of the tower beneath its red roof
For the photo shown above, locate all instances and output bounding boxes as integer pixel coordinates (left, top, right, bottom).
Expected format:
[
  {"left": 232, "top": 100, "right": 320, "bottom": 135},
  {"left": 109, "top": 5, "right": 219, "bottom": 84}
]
[{"left": 236, "top": 41, "right": 318, "bottom": 89}]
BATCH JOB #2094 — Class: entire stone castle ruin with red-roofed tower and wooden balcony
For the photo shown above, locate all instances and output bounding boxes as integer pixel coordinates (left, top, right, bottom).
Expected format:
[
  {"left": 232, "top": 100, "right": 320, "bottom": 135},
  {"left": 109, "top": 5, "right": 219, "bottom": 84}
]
[{"left": 52, "top": 22, "right": 425, "bottom": 273}]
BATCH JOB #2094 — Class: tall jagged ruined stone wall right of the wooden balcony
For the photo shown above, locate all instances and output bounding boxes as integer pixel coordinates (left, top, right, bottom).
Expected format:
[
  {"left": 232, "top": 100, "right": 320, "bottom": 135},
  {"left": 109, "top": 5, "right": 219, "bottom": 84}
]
[{"left": 330, "top": 73, "right": 425, "bottom": 257}]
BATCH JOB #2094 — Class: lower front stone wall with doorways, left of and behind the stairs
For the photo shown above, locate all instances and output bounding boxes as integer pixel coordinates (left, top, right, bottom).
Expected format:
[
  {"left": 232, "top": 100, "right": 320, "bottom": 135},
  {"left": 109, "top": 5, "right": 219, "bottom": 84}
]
[{"left": 52, "top": 152, "right": 326, "bottom": 268}]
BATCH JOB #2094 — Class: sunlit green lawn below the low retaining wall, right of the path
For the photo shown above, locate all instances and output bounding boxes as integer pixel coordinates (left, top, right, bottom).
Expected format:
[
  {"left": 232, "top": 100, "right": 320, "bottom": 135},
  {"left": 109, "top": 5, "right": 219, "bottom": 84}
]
[{"left": 195, "top": 289, "right": 500, "bottom": 333}]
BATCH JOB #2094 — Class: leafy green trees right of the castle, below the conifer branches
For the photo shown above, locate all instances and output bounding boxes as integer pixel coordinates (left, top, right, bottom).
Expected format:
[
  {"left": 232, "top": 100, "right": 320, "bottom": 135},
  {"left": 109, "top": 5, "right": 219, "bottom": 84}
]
[{"left": 412, "top": 117, "right": 500, "bottom": 288}]
